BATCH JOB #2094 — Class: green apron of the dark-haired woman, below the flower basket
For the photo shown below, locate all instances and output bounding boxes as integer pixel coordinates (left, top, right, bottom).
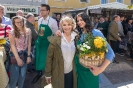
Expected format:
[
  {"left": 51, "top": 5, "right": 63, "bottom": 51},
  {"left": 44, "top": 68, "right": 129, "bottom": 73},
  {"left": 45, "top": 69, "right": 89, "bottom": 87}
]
[{"left": 74, "top": 40, "right": 99, "bottom": 88}]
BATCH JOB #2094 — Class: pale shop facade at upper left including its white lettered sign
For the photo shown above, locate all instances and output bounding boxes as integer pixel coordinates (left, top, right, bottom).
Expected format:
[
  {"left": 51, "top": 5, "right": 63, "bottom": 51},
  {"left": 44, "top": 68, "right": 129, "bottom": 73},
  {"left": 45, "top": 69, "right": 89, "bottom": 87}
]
[{"left": 0, "top": 0, "right": 47, "bottom": 18}]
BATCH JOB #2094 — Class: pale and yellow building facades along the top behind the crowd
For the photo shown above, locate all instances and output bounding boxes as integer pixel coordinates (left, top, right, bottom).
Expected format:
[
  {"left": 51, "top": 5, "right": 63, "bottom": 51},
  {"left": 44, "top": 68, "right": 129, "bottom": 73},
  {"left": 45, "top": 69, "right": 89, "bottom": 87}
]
[{"left": 1, "top": 0, "right": 133, "bottom": 17}]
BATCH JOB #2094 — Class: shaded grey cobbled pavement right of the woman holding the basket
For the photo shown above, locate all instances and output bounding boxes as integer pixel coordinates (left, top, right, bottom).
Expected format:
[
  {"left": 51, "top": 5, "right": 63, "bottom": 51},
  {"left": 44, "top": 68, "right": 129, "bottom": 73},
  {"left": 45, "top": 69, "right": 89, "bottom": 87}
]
[{"left": 104, "top": 55, "right": 133, "bottom": 84}]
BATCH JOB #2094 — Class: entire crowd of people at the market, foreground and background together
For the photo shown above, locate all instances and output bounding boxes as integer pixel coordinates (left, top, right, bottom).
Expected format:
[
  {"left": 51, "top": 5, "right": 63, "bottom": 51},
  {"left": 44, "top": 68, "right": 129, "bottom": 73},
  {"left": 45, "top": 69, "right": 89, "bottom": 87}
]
[{"left": 0, "top": 4, "right": 133, "bottom": 88}]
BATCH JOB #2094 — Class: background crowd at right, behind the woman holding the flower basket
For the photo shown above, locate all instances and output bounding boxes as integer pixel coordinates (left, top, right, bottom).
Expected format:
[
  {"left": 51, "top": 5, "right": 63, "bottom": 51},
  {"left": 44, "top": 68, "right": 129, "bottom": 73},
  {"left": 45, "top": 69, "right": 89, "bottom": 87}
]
[{"left": 94, "top": 14, "right": 133, "bottom": 63}]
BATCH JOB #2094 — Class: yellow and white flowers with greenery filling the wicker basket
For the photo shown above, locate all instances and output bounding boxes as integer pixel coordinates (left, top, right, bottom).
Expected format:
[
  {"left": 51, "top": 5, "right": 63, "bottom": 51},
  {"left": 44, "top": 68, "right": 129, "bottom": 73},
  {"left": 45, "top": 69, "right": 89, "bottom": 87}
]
[{"left": 78, "top": 34, "right": 107, "bottom": 56}]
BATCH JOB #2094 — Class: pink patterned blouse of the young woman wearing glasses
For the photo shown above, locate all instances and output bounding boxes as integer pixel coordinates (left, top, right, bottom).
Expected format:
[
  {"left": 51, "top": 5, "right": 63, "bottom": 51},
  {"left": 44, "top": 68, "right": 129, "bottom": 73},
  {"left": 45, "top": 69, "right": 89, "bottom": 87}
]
[{"left": 10, "top": 28, "right": 30, "bottom": 52}]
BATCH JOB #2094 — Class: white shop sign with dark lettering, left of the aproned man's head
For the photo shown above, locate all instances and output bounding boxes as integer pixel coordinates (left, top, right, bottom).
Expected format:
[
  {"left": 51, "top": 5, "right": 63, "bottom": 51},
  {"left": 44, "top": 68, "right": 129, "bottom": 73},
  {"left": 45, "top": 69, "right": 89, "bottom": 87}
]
[{"left": 6, "top": 6, "right": 38, "bottom": 14}]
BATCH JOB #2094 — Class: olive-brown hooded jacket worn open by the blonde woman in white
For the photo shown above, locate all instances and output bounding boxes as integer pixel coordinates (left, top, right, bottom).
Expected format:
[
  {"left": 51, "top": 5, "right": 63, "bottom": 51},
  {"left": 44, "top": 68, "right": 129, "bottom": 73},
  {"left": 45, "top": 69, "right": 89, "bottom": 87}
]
[{"left": 41, "top": 36, "right": 77, "bottom": 88}]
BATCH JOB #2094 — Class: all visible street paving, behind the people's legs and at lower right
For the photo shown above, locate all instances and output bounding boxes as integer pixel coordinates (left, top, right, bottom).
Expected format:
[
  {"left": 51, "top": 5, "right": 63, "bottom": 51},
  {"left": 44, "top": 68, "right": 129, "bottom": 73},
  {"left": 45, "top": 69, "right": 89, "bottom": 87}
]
[{"left": 24, "top": 55, "right": 133, "bottom": 88}]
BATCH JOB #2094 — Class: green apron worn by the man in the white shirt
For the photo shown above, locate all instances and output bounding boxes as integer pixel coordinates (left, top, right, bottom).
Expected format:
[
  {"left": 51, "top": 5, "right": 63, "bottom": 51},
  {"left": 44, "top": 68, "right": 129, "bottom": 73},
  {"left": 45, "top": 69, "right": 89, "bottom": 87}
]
[{"left": 35, "top": 18, "right": 52, "bottom": 70}]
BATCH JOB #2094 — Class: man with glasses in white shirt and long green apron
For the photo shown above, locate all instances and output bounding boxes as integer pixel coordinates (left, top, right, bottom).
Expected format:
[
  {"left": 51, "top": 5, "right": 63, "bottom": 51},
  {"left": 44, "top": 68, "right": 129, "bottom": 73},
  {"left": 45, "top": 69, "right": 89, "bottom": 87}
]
[{"left": 32, "top": 4, "right": 58, "bottom": 84}]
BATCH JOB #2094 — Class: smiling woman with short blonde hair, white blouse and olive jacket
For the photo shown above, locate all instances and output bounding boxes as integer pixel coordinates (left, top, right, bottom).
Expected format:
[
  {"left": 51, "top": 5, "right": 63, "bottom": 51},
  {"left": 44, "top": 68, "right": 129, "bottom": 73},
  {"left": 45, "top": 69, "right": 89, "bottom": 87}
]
[{"left": 42, "top": 16, "right": 77, "bottom": 88}]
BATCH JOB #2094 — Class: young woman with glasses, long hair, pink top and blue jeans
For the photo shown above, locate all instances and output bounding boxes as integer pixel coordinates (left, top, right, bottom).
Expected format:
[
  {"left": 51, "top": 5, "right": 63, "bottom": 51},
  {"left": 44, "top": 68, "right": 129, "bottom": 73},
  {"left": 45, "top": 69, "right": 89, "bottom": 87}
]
[{"left": 9, "top": 16, "right": 31, "bottom": 88}]
